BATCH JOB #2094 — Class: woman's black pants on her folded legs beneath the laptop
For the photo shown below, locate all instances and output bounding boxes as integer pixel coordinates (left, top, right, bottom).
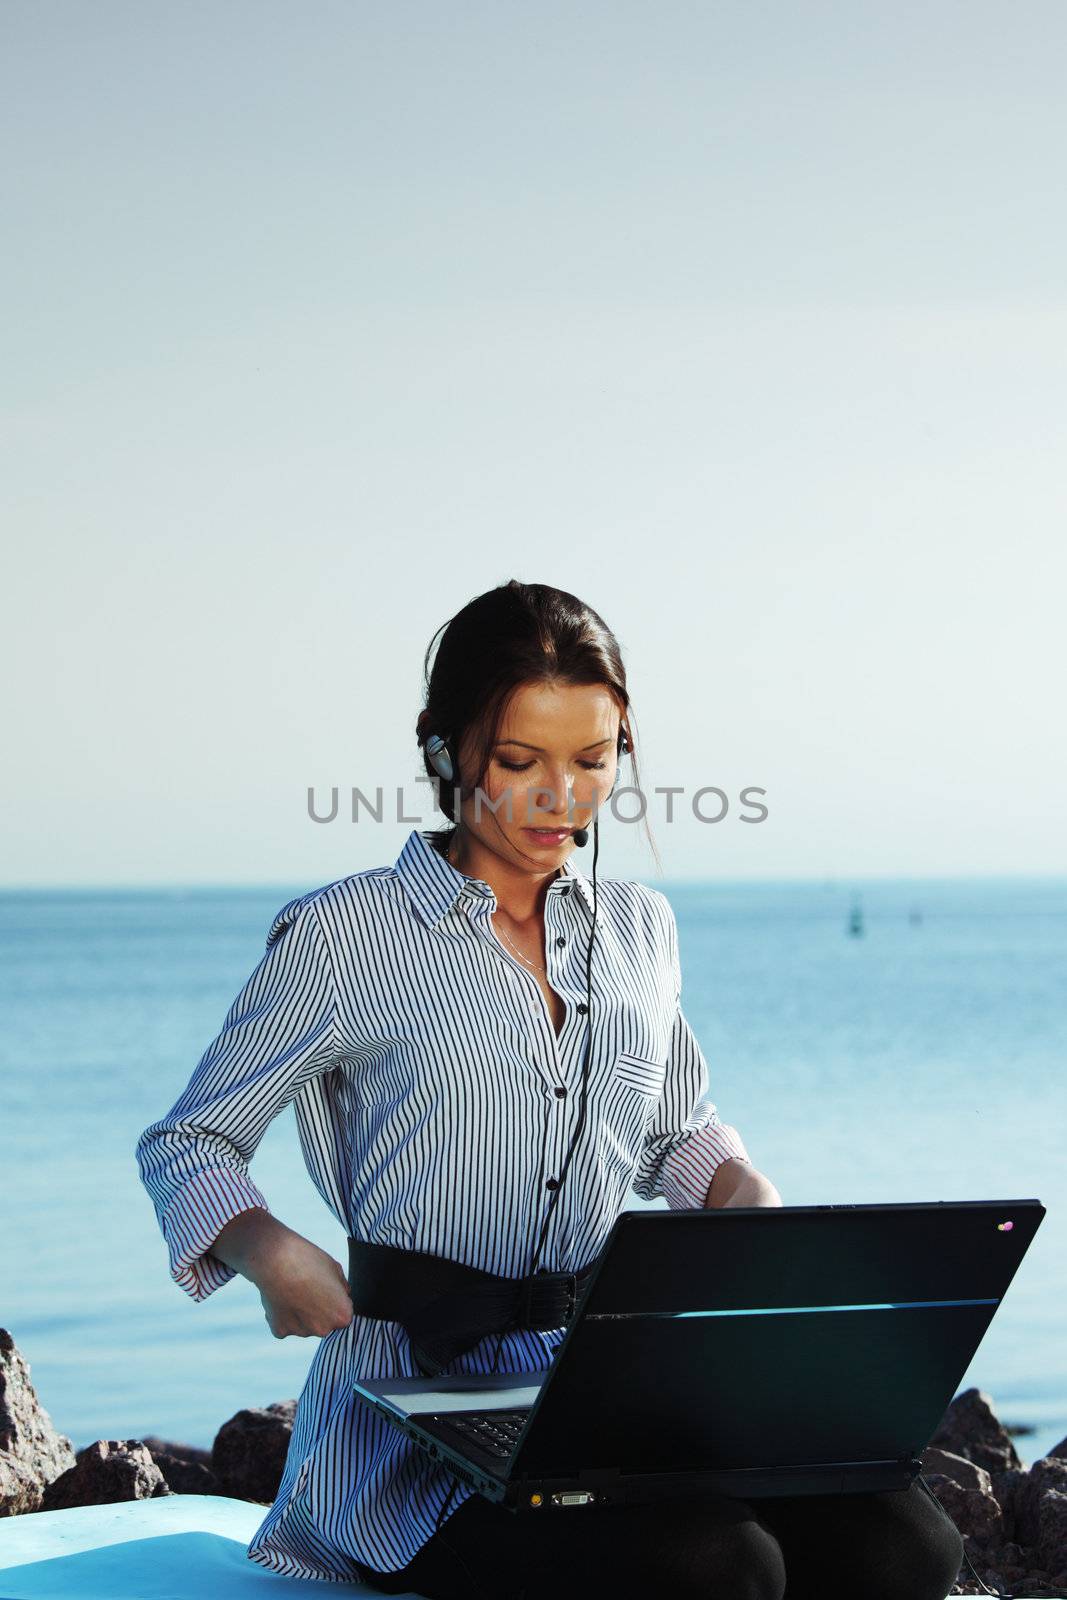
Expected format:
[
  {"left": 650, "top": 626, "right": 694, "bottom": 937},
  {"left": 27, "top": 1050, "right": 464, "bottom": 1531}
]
[{"left": 361, "top": 1482, "right": 963, "bottom": 1600}]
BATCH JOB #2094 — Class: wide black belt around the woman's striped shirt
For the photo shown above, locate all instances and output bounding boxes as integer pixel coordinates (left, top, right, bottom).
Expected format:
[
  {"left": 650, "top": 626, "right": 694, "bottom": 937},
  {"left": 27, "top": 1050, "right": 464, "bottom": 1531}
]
[{"left": 349, "top": 1234, "right": 597, "bottom": 1378}]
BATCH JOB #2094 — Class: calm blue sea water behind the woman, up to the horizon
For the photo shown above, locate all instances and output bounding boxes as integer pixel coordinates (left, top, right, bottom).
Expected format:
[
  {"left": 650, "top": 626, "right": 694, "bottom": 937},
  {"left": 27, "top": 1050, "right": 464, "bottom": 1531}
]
[{"left": 0, "top": 880, "right": 1067, "bottom": 1461}]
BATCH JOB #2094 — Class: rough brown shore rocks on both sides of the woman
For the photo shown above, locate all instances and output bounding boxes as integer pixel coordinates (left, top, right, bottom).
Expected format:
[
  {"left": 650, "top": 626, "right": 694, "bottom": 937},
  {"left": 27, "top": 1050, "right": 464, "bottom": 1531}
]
[{"left": 0, "top": 1328, "right": 1067, "bottom": 1600}]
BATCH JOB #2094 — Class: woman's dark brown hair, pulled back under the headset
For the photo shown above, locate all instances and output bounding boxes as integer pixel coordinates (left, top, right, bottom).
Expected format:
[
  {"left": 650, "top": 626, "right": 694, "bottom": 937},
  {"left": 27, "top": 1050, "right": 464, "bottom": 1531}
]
[{"left": 416, "top": 578, "right": 659, "bottom": 861}]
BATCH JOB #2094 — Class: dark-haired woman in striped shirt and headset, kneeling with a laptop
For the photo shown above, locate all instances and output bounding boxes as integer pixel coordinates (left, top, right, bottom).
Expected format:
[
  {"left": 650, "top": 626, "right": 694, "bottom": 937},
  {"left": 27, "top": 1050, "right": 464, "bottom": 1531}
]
[{"left": 138, "top": 581, "right": 961, "bottom": 1600}]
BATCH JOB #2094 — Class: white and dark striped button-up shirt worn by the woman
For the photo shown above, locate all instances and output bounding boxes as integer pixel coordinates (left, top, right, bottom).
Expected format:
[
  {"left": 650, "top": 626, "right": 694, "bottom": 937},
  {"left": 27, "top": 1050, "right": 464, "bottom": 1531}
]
[{"left": 136, "top": 829, "right": 749, "bottom": 1581}]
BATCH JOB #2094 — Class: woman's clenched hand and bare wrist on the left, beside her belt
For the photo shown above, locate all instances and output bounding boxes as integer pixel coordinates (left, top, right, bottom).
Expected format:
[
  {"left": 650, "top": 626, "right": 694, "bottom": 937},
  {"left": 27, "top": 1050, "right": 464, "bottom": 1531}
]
[{"left": 211, "top": 1206, "right": 354, "bottom": 1339}]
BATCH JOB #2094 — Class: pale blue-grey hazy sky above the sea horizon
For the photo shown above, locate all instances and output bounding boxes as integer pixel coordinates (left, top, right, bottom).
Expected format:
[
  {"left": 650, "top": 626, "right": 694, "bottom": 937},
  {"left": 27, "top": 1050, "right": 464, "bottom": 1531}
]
[{"left": 0, "top": 0, "right": 1067, "bottom": 888}]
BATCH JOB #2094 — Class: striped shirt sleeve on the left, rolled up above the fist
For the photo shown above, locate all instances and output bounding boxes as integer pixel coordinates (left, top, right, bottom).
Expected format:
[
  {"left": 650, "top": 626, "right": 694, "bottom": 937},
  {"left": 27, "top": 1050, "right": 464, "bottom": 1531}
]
[{"left": 136, "top": 898, "right": 336, "bottom": 1301}]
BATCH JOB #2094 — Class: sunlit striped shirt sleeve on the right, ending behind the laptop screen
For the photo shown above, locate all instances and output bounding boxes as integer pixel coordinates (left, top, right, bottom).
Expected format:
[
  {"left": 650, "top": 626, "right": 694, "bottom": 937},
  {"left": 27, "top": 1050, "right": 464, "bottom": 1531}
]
[{"left": 633, "top": 891, "right": 752, "bottom": 1211}]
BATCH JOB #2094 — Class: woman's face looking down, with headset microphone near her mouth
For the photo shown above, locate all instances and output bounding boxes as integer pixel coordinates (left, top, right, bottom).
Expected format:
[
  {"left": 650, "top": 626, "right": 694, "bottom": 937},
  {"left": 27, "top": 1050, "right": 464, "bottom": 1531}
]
[{"left": 459, "top": 683, "right": 621, "bottom": 869}]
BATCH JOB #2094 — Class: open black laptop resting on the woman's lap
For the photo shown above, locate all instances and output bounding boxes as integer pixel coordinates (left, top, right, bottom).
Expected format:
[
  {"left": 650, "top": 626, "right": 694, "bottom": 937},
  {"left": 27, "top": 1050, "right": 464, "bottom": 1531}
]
[{"left": 355, "top": 1200, "right": 1045, "bottom": 1510}]
